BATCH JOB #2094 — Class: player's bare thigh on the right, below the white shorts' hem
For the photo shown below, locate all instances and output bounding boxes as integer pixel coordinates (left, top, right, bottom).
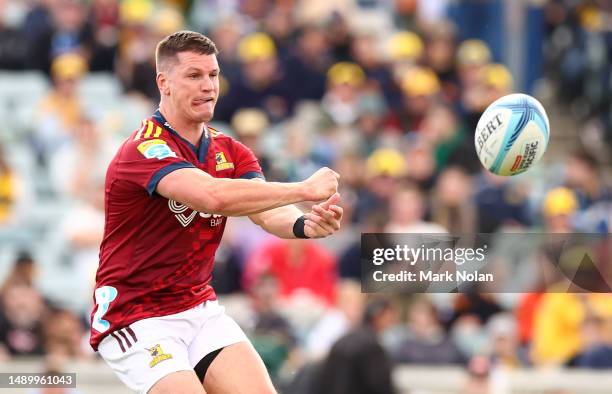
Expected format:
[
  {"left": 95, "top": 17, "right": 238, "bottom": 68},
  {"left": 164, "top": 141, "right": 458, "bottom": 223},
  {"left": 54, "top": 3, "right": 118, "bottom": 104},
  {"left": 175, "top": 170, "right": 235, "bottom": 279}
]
[{"left": 204, "top": 342, "right": 276, "bottom": 394}]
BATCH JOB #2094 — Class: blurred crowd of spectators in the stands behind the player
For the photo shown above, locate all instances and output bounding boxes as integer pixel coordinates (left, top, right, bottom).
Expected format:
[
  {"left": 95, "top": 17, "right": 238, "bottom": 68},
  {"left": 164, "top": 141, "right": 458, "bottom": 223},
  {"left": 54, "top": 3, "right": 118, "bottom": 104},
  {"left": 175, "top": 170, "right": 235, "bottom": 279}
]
[{"left": 0, "top": 0, "right": 612, "bottom": 394}]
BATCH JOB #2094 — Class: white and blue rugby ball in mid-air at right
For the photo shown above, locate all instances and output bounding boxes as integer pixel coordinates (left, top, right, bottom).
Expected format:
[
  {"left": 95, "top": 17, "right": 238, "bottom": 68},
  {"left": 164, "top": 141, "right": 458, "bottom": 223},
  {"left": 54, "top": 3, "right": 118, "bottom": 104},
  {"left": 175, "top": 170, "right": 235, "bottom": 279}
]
[{"left": 474, "top": 94, "right": 550, "bottom": 176}]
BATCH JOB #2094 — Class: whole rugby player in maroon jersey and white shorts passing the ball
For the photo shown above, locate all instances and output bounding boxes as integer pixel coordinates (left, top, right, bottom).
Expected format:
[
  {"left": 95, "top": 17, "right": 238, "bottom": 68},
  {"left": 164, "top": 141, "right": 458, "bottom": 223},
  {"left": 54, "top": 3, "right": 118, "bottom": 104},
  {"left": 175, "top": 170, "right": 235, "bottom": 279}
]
[{"left": 90, "top": 31, "right": 343, "bottom": 394}]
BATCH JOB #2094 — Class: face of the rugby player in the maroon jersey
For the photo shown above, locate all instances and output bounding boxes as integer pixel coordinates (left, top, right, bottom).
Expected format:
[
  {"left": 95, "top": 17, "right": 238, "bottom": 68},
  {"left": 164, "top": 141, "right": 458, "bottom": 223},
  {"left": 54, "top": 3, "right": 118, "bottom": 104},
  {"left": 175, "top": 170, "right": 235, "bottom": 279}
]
[{"left": 168, "top": 52, "right": 219, "bottom": 123}]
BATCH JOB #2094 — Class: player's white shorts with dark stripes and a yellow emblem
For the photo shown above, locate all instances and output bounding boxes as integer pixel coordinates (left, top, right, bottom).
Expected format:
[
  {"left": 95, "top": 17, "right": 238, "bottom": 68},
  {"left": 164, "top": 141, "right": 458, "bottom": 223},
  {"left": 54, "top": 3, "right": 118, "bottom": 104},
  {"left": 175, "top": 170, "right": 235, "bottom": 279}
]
[{"left": 98, "top": 301, "right": 248, "bottom": 393}]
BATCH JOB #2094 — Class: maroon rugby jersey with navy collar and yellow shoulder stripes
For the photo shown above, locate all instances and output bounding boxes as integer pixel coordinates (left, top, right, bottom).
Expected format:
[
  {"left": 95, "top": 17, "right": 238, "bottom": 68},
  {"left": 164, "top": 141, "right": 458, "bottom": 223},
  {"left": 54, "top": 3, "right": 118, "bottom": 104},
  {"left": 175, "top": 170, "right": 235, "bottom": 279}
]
[{"left": 90, "top": 111, "right": 263, "bottom": 350}]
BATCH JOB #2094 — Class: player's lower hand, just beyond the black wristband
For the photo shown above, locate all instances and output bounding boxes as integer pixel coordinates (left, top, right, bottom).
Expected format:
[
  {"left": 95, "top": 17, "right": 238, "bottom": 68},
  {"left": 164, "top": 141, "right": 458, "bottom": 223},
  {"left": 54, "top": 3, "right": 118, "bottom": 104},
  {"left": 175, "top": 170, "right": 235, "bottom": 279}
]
[{"left": 304, "top": 193, "right": 343, "bottom": 238}]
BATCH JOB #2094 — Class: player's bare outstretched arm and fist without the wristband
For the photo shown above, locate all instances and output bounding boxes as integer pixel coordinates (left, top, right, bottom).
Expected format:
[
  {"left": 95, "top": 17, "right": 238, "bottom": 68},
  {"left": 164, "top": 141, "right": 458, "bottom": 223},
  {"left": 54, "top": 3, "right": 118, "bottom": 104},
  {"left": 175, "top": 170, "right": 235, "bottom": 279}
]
[{"left": 156, "top": 168, "right": 339, "bottom": 216}]
